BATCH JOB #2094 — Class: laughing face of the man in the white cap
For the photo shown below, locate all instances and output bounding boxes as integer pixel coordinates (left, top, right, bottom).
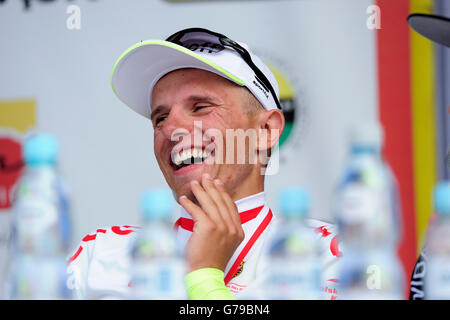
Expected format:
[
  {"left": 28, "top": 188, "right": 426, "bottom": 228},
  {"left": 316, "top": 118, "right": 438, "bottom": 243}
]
[{"left": 151, "top": 69, "right": 257, "bottom": 200}]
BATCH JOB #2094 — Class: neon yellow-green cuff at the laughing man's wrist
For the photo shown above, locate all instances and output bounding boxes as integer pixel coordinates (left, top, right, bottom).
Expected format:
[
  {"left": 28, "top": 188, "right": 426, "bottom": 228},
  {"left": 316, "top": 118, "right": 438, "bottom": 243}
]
[{"left": 184, "top": 268, "right": 236, "bottom": 300}]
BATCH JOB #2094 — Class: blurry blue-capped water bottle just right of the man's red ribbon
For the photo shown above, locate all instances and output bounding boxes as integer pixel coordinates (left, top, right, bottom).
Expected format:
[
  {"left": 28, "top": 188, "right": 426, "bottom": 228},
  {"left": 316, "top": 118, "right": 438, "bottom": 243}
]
[{"left": 265, "top": 188, "right": 322, "bottom": 300}]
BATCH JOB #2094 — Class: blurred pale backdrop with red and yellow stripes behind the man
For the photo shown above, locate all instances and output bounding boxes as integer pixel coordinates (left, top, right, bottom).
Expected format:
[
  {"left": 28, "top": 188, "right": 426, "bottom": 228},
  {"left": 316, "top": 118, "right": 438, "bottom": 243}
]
[{"left": 0, "top": 0, "right": 450, "bottom": 298}]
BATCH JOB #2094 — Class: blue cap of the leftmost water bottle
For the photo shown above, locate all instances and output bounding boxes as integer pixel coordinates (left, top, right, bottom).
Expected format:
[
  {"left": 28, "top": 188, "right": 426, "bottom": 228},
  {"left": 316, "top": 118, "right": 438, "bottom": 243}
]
[{"left": 23, "top": 133, "right": 59, "bottom": 166}]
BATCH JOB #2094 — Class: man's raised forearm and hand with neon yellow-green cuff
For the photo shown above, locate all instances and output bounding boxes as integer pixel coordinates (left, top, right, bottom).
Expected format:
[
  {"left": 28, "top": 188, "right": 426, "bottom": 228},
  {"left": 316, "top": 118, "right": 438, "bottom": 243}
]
[{"left": 179, "top": 174, "right": 244, "bottom": 300}]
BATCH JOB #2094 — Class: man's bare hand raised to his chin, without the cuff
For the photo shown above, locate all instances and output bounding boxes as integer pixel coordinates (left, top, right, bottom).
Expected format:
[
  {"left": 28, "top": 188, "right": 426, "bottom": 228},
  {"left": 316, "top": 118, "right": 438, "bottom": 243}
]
[{"left": 179, "top": 174, "right": 244, "bottom": 272}]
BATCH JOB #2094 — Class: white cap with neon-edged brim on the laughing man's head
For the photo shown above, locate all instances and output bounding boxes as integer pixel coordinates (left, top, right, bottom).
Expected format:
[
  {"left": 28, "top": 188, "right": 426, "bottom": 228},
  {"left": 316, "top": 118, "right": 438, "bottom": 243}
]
[{"left": 111, "top": 28, "right": 279, "bottom": 118}]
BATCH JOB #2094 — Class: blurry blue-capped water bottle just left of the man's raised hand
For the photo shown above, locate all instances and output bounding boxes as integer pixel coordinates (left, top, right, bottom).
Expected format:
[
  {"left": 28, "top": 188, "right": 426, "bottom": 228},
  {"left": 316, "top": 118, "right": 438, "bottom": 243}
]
[{"left": 131, "top": 189, "right": 187, "bottom": 300}]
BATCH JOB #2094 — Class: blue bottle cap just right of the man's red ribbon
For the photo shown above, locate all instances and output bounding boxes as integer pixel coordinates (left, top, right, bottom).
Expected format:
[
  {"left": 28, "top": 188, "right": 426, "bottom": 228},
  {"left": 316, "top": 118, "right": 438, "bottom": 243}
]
[{"left": 279, "top": 187, "right": 310, "bottom": 217}]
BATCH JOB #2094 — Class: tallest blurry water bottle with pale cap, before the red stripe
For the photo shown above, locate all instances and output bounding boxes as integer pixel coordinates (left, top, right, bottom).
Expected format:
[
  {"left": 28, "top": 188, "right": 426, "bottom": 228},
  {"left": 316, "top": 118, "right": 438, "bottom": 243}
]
[{"left": 334, "top": 123, "right": 405, "bottom": 300}]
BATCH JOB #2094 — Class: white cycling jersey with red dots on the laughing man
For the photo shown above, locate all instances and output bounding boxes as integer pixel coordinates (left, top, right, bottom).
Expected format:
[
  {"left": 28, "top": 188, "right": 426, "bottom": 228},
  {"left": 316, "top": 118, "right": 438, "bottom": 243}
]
[{"left": 68, "top": 192, "right": 340, "bottom": 299}]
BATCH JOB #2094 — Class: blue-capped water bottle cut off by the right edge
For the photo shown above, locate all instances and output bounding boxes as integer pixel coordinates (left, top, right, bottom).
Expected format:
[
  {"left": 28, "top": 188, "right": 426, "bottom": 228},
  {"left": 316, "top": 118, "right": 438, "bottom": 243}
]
[{"left": 424, "top": 181, "right": 450, "bottom": 300}]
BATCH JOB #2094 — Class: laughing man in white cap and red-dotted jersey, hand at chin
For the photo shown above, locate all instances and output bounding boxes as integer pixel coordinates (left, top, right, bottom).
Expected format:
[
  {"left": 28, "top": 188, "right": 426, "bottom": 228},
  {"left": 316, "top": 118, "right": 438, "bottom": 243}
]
[{"left": 69, "top": 28, "right": 340, "bottom": 299}]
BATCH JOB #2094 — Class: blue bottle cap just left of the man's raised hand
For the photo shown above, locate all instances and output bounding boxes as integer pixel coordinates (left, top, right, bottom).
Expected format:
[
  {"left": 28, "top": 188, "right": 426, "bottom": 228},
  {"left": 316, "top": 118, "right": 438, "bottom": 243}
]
[{"left": 140, "top": 189, "right": 174, "bottom": 221}]
